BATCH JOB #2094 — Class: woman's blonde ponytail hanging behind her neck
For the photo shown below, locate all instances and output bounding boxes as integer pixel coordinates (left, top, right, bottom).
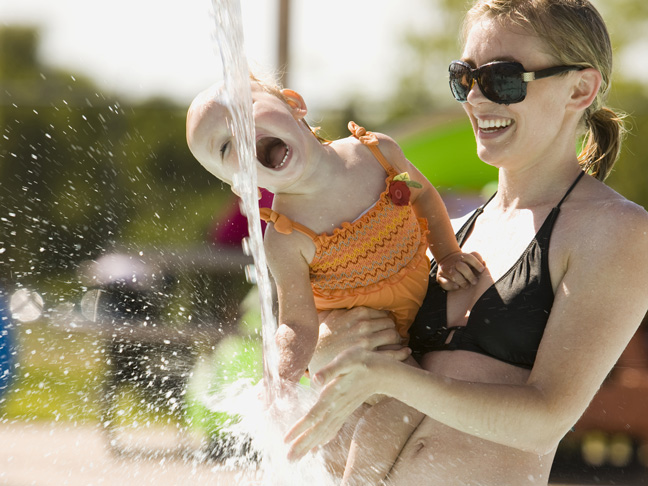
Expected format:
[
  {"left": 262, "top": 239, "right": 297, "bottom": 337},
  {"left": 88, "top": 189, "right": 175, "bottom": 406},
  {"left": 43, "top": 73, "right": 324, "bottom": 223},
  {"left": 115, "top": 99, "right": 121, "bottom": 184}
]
[{"left": 578, "top": 107, "right": 626, "bottom": 181}]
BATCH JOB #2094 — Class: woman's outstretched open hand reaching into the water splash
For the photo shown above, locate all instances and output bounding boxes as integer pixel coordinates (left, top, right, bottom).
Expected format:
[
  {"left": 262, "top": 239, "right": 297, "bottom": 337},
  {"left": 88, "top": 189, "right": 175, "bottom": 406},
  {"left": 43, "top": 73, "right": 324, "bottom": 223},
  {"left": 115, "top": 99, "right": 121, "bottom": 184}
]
[{"left": 284, "top": 346, "right": 411, "bottom": 460}]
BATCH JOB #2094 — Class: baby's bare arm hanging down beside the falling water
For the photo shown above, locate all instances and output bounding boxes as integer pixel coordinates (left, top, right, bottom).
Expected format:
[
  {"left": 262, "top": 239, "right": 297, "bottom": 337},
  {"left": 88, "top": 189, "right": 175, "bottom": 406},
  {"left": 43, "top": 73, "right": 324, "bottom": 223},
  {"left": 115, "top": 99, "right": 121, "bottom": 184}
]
[{"left": 264, "top": 225, "right": 319, "bottom": 382}]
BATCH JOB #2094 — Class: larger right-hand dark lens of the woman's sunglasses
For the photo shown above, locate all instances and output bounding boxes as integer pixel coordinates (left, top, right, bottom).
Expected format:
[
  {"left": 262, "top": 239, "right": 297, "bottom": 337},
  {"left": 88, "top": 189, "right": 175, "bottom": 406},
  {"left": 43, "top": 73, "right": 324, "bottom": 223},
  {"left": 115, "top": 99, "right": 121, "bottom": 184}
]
[{"left": 479, "top": 62, "right": 526, "bottom": 104}]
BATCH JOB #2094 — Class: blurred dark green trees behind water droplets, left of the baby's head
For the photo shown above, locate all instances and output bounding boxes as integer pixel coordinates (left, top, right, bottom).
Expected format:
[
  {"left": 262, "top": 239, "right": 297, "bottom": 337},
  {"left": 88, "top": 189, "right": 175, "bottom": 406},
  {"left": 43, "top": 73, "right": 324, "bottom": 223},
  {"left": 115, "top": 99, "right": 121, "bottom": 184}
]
[{"left": 0, "top": 28, "right": 229, "bottom": 296}]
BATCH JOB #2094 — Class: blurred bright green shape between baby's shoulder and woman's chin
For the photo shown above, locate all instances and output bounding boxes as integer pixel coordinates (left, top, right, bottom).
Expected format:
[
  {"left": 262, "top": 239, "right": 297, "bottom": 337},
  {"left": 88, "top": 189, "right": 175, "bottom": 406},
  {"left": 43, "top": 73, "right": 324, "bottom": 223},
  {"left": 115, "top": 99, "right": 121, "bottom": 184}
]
[{"left": 398, "top": 120, "right": 497, "bottom": 193}]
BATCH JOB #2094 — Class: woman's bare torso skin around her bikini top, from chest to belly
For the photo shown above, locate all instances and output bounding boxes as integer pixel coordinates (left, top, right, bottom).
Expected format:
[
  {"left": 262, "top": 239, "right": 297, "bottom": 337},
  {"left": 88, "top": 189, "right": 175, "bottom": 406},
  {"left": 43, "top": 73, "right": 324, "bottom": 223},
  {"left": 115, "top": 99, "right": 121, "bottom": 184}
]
[{"left": 316, "top": 179, "right": 618, "bottom": 486}]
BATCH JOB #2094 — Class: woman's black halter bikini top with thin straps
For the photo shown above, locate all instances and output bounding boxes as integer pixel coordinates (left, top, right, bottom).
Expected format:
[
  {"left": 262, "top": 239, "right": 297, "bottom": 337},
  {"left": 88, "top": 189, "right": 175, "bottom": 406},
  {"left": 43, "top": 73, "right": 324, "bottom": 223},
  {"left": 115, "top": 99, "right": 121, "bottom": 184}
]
[{"left": 409, "top": 172, "right": 585, "bottom": 369}]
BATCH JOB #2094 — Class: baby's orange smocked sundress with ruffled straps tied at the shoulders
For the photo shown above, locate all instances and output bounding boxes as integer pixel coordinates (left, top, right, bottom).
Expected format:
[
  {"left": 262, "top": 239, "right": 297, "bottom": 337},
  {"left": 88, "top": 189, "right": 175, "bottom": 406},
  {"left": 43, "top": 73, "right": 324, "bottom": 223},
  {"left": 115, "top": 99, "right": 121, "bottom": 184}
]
[{"left": 261, "top": 122, "right": 430, "bottom": 339}]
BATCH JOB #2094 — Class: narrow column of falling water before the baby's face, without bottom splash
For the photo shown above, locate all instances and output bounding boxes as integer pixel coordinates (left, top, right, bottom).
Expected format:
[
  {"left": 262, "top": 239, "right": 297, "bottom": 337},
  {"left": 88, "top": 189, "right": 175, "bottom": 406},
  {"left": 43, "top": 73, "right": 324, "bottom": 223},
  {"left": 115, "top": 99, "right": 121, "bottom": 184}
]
[{"left": 212, "top": 0, "right": 278, "bottom": 402}]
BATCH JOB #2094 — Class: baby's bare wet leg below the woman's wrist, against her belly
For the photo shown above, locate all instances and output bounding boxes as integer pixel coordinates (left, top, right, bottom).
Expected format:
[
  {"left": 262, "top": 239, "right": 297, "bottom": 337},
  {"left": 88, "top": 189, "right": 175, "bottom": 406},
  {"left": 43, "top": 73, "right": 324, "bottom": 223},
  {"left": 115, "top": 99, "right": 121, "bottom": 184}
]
[{"left": 342, "top": 398, "right": 424, "bottom": 486}]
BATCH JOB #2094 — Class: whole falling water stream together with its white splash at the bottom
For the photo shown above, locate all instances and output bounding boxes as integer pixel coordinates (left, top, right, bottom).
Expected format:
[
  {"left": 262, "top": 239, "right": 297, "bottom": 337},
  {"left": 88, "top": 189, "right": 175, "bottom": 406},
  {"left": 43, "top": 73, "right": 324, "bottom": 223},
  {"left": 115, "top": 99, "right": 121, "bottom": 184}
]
[{"left": 208, "top": 4, "right": 336, "bottom": 486}]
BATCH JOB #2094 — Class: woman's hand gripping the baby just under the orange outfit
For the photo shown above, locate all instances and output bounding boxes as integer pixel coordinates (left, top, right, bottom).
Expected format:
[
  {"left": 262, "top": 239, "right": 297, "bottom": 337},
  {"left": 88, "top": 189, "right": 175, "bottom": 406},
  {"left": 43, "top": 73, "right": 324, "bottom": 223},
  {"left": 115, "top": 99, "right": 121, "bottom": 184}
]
[{"left": 309, "top": 307, "right": 401, "bottom": 376}]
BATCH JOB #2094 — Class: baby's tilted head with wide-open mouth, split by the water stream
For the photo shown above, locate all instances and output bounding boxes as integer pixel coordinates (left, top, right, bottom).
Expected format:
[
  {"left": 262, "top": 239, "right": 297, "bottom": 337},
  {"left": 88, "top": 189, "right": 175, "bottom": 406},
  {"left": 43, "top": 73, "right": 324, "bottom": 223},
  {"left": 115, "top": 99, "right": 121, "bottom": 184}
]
[{"left": 187, "top": 76, "right": 325, "bottom": 189}]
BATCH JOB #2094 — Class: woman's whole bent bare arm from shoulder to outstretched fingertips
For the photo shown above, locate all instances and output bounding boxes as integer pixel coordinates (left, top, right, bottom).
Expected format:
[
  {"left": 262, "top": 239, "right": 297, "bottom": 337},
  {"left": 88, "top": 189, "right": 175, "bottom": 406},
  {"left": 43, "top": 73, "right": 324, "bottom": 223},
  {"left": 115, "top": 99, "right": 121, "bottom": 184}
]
[{"left": 286, "top": 201, "right": 648, "bottom": 458}]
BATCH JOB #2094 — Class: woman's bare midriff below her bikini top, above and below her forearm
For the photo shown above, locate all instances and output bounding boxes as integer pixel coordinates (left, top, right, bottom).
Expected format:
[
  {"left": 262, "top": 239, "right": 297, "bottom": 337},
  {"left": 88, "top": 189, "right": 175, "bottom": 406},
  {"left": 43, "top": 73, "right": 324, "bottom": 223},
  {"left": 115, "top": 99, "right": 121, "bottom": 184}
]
[{"left": 390, "top": 351, "right": 554, "bottom": 486}]
